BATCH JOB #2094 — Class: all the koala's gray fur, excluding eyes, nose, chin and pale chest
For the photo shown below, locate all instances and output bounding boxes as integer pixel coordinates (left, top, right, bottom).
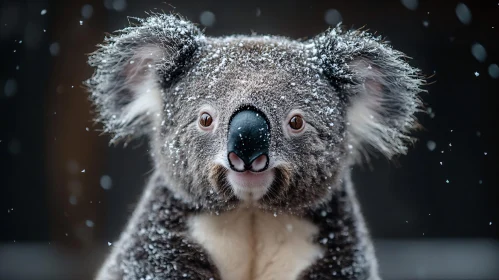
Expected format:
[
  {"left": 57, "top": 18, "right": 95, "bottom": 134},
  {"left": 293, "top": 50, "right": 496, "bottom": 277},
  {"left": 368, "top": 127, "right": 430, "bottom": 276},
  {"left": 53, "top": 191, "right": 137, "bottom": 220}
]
[{"left": 86, "top": 14, "right": 422, "bottom": 279}]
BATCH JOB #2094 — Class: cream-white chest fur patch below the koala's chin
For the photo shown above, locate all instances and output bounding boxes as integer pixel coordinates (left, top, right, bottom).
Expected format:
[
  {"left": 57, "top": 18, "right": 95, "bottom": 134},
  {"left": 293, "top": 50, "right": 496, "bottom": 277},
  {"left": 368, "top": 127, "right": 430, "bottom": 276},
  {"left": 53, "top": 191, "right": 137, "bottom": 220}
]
[{"left": 189, "top": 209, "right": 322, "bottom": 280}]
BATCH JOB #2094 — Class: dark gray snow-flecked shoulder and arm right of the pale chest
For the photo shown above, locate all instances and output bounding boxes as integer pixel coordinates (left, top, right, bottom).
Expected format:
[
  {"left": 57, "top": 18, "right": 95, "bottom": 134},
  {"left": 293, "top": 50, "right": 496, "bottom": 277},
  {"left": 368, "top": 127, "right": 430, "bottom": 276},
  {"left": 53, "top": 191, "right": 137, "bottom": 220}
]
[{"left": 302, "top": 171, "right": 379, "bottom": 280}]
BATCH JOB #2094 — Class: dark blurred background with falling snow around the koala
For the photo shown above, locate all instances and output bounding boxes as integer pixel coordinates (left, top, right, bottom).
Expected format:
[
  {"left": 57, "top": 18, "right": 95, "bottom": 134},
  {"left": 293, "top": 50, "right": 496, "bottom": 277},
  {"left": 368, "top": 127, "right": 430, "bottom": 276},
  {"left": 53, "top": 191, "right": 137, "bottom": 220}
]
[{"left": 0, "top": 0, "right": 499, "bottom": 280}]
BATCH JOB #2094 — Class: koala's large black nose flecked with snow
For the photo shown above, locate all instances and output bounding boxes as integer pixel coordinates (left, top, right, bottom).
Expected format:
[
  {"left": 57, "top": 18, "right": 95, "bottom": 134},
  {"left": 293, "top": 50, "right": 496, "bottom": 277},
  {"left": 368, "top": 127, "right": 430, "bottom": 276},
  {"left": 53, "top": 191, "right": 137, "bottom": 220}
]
[{"left": 227, "top": 109, "right": 270, "bottom": 172}]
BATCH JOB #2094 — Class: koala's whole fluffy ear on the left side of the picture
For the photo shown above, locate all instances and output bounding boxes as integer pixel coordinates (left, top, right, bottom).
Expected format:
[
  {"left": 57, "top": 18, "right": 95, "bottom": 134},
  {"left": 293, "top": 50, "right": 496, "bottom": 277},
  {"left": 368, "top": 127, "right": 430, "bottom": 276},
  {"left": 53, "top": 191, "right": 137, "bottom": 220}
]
[{"left": 85, "top": 14, "right": 203, "bottom": 142}]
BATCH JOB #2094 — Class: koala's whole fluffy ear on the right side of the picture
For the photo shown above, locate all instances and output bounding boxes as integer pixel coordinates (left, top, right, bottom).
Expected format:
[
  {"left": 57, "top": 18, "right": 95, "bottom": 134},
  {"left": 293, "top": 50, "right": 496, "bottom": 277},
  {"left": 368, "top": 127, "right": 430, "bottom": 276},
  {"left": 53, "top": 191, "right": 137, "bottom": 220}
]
[{"left": 312, "top": 26, "right": 423, "bottom": 162}]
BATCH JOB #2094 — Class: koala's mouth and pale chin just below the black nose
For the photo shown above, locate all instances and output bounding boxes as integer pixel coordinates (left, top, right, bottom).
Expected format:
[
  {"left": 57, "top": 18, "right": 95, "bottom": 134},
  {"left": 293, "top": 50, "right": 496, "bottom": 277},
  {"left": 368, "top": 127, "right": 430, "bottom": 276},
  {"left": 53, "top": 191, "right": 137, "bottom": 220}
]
[{"left": 210, "top": 164, "right": 291, "bottom": 204}]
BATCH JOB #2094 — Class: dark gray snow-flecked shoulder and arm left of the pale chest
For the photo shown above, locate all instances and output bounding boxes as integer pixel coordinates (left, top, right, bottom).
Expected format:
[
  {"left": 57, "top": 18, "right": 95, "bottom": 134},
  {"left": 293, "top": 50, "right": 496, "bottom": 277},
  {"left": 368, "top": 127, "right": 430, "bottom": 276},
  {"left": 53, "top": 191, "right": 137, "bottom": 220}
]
[{"left": 97, "top": 173, "right": 219, "bottom": 280}]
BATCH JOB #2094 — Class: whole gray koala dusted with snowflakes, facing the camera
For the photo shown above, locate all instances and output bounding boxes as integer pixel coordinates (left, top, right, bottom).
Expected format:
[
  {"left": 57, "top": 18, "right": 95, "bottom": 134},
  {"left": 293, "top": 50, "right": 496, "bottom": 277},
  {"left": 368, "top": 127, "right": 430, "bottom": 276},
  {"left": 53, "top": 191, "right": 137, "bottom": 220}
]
[{"left": 85, "top": 14, "right": 423, "bottom": 280}]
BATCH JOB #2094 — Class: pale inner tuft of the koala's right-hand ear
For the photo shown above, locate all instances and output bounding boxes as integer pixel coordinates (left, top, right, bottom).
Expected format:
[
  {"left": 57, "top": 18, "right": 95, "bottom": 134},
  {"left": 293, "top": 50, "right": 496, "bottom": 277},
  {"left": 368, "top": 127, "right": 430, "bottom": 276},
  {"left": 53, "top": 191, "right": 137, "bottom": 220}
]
[{"left": 347, "top": 59, "right": 419, "bottom": 158}]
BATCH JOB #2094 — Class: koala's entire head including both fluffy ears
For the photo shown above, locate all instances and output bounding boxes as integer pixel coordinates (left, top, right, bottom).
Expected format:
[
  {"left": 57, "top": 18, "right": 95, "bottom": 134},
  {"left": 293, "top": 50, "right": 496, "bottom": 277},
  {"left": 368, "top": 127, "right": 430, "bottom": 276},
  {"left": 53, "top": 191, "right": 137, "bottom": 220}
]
[{"left": 86, "top": 15, "right": 422, "bottom": 212}]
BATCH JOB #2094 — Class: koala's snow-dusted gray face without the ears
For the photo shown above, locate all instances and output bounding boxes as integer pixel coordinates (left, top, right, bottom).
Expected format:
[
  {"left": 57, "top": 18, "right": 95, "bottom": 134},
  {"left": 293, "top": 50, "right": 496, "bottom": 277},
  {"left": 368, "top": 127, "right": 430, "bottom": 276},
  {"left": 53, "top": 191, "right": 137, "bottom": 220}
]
[{"left": 155, "top": 37, "right": 346, "bottom": 212}]
